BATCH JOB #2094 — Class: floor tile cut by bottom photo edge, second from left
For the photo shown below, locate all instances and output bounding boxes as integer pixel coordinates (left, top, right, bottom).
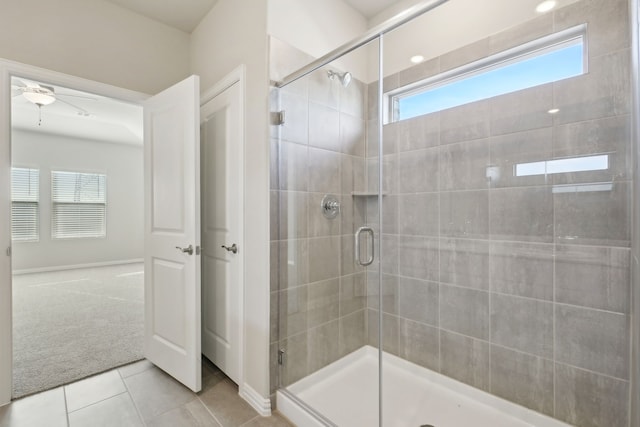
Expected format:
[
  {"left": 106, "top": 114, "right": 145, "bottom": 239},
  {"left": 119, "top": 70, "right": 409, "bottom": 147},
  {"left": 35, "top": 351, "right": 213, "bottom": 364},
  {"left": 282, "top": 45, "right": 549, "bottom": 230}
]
[{"left": 69, "top": 393, "right": 144, "bottom": 427}]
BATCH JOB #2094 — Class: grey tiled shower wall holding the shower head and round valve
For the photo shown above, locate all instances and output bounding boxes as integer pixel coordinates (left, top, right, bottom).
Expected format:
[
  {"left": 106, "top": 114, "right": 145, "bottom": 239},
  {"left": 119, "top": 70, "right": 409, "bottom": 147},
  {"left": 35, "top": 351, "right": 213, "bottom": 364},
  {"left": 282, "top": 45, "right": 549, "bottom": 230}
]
[{"left": 270, "top": 39, "right": 366, "bottom": 391}]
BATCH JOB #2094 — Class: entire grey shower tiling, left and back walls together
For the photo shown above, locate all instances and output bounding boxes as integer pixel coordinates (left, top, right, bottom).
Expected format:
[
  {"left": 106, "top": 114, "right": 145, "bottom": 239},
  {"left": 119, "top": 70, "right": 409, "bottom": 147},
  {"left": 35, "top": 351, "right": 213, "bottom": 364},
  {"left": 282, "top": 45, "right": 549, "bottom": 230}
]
[{"left": 271, "top": 0, "right": 632, "bottom": 427}]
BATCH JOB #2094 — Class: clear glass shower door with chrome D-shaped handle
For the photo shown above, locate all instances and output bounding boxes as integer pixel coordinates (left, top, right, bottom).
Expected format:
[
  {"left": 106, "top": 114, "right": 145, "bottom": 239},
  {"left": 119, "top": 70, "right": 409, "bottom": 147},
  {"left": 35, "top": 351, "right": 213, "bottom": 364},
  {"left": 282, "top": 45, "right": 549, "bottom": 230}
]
[{"left": 271, "top": 41, "right": 379, "bottom": 425}]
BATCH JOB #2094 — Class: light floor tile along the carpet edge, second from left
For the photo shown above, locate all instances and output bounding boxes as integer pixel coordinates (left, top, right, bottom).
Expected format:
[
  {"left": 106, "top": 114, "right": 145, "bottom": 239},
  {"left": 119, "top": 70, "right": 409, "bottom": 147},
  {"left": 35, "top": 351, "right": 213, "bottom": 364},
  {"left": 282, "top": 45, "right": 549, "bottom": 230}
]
[{"left": 64, "top": 370, "right": 127, "bottom": 412}]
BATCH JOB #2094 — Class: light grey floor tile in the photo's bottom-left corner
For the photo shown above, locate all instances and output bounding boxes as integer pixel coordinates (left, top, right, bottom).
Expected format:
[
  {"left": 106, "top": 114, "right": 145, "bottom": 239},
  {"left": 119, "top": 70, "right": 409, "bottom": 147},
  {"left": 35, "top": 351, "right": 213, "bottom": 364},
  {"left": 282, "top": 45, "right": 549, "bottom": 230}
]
[{"left": 0, "top": 387, "right": 67, "bottom": 427}]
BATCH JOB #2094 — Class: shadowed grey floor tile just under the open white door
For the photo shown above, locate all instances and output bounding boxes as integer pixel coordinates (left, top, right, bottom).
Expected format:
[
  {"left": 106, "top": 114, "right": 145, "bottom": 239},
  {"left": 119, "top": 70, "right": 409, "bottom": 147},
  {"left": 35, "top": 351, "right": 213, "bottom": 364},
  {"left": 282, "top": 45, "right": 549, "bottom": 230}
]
[{"left": 124, "top": 367, "right": 196, "bottom": 421}]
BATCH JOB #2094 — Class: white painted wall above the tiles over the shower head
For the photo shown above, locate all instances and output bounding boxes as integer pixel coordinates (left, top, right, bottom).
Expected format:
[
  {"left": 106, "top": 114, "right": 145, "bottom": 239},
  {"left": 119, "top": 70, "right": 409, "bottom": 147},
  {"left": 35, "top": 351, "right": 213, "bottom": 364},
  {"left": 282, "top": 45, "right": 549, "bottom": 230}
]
[{"left": 267, "top": 0, "right": 367, "bottom": 81}]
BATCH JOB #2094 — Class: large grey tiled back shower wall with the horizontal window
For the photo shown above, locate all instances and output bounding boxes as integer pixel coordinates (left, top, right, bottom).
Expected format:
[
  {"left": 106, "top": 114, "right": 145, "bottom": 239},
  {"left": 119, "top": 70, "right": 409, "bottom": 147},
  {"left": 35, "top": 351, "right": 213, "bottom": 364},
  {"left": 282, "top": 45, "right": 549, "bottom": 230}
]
[{"left": 367, "top": 0, "right": 632, "bottom": 427}]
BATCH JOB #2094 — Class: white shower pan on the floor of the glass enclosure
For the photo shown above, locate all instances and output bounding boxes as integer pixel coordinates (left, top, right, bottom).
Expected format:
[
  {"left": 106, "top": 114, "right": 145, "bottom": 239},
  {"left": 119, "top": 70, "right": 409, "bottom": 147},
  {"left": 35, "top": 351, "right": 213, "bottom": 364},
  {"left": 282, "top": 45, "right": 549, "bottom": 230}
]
[{"left": 277, "top": 346, "right": 569, "bottom": 427}]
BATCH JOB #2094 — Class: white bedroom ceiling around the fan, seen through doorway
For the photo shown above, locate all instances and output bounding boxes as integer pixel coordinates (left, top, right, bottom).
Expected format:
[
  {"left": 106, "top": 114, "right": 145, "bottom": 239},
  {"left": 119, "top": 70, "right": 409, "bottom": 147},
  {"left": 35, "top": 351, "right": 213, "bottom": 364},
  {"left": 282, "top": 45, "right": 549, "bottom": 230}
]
[{"left": 11, "top": 77, "right": 143, "bottom": 145}]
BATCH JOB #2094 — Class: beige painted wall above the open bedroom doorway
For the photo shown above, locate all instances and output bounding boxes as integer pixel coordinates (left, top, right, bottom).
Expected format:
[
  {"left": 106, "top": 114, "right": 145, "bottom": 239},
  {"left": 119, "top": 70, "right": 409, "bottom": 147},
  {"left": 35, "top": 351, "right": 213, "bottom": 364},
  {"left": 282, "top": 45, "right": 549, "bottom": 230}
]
[{"left": 0, "top": 0, "right": 189, "bottom": 94}]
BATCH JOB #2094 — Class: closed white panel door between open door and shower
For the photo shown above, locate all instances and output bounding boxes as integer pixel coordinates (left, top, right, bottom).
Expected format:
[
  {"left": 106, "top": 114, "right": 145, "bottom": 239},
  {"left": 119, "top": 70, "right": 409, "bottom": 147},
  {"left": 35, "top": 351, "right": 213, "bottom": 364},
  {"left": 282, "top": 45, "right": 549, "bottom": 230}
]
[{"left": 200, "top": 82, "right": 243, "bottom": 383}]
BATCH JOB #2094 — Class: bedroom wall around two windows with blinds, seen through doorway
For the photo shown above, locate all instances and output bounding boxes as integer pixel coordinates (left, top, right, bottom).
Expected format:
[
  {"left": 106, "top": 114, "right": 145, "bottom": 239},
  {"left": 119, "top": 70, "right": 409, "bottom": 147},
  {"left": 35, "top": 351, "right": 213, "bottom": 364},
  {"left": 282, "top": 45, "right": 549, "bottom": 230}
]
[{"left": 12, "top": 130, "right": 144, "bottom": 272}]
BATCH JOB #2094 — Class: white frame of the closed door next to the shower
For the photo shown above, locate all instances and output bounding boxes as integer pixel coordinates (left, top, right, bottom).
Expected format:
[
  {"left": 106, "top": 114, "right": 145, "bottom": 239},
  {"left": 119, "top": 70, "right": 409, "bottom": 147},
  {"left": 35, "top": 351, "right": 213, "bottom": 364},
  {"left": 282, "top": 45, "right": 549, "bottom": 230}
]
[{"left": 200, "top": 65, "right": 256, "bottom": 415}]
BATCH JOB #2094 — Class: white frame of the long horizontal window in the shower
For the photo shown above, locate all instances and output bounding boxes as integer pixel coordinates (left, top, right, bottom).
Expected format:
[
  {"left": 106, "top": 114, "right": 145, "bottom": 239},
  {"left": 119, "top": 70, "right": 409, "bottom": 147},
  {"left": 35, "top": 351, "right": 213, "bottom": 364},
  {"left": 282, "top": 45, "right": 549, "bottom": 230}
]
[{"left": 383, "top": 24, "right": 589, "bottom": 124}]
